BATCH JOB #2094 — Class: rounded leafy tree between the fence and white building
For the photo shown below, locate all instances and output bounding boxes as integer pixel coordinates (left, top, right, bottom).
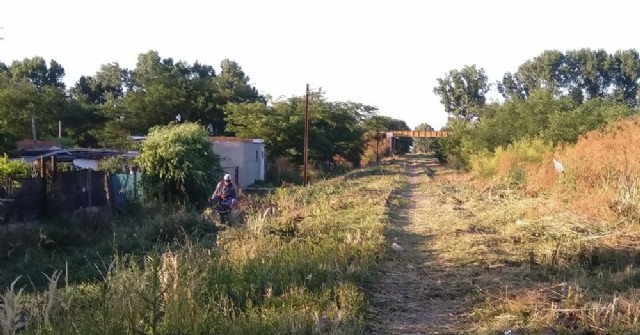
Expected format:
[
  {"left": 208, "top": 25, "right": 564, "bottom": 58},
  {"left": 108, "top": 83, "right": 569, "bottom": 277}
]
[{"left": 137, "top": 122, "right": 223, "bottom": 205}]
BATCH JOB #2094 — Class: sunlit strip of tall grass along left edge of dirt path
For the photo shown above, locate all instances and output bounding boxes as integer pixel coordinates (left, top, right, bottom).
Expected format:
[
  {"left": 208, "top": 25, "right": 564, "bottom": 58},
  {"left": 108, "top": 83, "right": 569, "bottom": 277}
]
[{"left": 0, "top": 165, "right": 402, "bottom": 334}]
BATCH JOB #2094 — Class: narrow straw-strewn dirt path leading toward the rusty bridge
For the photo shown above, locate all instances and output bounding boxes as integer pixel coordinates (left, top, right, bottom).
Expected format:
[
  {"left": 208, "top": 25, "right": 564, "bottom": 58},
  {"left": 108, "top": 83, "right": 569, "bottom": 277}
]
[{"left": 369, "top": 158, "right": 472, "bottom": 334}]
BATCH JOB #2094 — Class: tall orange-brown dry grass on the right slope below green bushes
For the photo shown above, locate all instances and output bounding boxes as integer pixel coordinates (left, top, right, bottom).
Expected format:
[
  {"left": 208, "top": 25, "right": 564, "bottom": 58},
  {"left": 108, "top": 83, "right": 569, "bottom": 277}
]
[{"left": 471, "top": 117, "right": 640, "bottom": 222}]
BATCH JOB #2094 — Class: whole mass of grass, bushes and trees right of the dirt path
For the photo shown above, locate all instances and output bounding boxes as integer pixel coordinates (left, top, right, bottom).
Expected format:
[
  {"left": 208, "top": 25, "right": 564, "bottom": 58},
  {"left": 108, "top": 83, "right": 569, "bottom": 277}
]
[{"left": 416, "top": 49, "right": 640, "bottom": 334}]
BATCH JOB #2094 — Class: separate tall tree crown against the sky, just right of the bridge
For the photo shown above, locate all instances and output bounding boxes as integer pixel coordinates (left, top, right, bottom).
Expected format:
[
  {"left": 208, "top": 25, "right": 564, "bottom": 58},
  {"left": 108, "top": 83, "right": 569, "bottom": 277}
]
[{"left": 433, "top": 65, "right": 489, "bottom": 121}]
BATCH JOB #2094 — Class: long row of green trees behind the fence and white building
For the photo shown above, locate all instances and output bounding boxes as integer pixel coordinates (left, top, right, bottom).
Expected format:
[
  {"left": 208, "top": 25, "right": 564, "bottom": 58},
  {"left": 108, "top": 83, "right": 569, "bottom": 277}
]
[{"left": 0, "top": 51, "right": 409, "bottom": 165}]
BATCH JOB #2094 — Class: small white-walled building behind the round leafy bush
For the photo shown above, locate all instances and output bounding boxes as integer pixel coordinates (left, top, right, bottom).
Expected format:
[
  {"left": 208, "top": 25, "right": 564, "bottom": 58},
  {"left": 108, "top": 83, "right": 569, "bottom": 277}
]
[{"left": 209, "top": 136, "right": 266, "bottom": 187}]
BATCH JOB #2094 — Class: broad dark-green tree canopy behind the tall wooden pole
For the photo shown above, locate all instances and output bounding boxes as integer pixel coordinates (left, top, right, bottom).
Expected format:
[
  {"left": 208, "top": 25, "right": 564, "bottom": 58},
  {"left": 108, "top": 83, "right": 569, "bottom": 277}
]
[{"left": 225, "top": 94, "right": 376, "bottom": 165}]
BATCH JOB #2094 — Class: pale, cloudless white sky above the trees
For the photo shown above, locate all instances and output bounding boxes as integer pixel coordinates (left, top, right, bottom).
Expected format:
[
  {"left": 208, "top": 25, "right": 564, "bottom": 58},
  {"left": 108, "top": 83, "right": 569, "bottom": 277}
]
[{"left": 0, "top": 0, "right": 640, "bottom": 129}]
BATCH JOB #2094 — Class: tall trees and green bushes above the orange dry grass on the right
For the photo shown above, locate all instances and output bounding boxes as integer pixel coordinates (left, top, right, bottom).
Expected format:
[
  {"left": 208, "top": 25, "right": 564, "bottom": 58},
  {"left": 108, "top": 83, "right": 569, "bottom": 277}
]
[{"left": 433, "top": 48, "right": 640, "bottom": 168}]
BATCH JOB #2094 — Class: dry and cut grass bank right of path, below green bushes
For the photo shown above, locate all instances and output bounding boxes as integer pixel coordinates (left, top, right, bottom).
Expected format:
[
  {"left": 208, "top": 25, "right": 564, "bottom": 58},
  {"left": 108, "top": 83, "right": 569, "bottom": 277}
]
[{"left": 444, "top": 118, "right": 640, "bottom": 334}]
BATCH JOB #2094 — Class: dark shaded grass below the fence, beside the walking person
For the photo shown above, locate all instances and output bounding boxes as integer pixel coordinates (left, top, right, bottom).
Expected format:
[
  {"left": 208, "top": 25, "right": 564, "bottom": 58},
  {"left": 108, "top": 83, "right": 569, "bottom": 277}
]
[{"left": 0, "top": 204, "right": 216, "bottom": 291}]
